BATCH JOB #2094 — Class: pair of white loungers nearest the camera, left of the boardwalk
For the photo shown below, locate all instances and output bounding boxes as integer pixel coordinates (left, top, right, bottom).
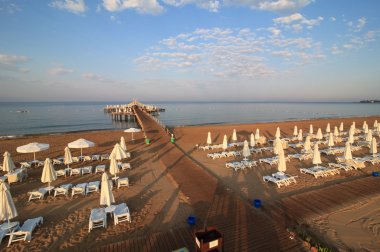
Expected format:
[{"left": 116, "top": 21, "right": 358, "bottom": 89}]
[{"left": 88, "top": 203, "right": 131, "bottom": 232}]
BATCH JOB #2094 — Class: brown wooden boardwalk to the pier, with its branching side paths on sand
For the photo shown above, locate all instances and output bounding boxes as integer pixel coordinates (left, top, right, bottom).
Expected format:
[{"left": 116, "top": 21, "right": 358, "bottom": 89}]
[{"left": 95, "top": 107, "right": 380, "bottom": 252}]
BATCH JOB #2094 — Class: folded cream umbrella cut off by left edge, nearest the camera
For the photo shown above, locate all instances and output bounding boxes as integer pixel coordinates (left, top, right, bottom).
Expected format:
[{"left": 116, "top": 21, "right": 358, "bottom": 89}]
[{"left": 0, "top": 180, "right": 18, "bottom": 227}]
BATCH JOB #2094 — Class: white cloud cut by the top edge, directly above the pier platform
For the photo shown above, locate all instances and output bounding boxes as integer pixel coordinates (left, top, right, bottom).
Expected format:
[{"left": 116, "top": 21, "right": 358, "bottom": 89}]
[{"left": 103, "top": 0, "right": 164, "bottom": 14}]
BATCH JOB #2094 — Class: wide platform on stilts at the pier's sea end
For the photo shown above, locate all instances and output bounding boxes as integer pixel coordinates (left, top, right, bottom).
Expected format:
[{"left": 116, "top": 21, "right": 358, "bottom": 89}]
[{"left": 104, "top": 100, "right": 165, "bottom": 122}]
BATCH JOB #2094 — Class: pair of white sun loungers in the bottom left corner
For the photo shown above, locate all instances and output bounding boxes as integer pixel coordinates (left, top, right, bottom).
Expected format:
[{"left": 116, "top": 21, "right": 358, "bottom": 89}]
[{"left": 0, "top": 217, "right": 43, "bottom": 247}]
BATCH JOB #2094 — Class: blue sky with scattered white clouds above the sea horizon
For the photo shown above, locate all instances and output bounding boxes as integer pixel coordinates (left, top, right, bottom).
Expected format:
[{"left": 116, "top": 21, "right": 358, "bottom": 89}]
[{"left": 0, "top": 0, "right": 380, "bottom": 102}]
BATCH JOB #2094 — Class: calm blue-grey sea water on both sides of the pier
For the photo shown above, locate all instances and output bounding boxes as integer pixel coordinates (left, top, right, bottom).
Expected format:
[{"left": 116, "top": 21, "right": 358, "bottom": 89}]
[{"left": 0, "top": 102, "right": 380, "bottom": 136}]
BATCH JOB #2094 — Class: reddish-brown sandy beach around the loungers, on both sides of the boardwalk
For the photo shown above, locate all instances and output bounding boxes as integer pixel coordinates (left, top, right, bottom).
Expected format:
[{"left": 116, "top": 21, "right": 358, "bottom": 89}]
[{"left": 0, "top": 117, "right": 379, "bottom": 251}]
